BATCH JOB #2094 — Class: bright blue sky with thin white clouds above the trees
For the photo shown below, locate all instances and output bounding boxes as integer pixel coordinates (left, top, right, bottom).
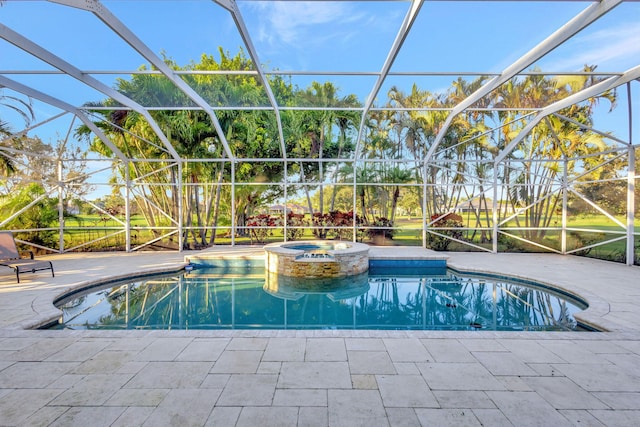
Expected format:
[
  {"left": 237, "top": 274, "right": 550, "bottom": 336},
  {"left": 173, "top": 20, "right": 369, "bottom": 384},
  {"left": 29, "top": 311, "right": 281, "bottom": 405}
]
[{"left": 0, "top": 0, "right": 640, "bottom": 196}]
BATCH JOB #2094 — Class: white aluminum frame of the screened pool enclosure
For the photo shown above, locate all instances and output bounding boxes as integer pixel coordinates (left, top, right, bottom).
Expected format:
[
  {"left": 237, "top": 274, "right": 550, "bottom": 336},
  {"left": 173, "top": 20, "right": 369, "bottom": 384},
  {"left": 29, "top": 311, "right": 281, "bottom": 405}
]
[{"left": 0, "top": 0, "right": 640, "bottom": 265}]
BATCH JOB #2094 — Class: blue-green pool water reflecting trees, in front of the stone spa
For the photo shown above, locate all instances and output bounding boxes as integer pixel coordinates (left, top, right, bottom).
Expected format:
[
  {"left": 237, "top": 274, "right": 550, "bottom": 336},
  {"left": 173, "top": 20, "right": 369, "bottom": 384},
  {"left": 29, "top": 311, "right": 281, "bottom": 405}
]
[{"left": 56, "top": 268, "right": 586, "bottom": 331}]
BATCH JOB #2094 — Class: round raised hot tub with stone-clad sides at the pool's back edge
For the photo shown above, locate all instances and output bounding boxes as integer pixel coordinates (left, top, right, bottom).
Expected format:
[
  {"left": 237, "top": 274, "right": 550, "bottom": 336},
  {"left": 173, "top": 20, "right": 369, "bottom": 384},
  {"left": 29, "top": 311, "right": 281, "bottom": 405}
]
[{"left": 264, "top": 240, "right": 369, "bottom": 279}]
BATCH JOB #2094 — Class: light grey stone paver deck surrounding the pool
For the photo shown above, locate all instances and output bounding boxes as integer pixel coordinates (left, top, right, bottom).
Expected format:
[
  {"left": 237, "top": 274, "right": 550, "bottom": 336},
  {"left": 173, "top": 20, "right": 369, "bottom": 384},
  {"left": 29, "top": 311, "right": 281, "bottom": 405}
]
[{"left": 0, "top": 247, "right": 640, "bottom": 426}]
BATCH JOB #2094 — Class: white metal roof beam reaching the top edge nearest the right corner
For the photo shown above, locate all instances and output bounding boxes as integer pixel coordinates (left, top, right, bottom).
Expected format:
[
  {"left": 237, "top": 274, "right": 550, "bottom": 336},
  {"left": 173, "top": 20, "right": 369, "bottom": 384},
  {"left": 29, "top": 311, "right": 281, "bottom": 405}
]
[{"left": 425, "top": 0, "right": 622, "bottom": 161}]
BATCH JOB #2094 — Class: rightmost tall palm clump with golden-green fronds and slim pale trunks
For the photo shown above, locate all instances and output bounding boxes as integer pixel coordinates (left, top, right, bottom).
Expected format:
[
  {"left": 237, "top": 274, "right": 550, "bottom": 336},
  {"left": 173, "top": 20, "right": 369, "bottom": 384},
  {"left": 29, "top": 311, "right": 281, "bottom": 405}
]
[{"left": 494, "top": 67, "right": 616, "bottom": 242}]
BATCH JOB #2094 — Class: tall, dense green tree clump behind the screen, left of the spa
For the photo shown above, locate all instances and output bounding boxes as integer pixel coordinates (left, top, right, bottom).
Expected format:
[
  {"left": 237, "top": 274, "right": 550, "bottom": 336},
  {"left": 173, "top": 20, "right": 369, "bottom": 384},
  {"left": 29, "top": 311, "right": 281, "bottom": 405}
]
[{"left": 78, "top": 49, "right": 291, "bottom": 245}]
